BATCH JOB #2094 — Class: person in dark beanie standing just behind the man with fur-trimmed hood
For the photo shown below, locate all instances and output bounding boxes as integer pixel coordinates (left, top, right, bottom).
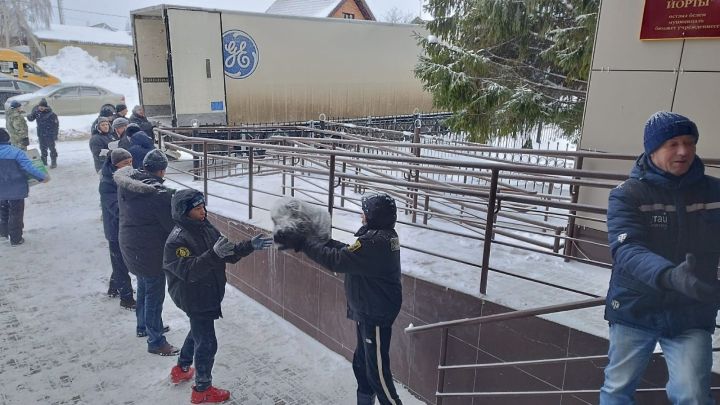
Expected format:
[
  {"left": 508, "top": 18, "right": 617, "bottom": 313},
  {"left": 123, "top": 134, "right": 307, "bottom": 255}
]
[{"left": 98, "top": 148, "right": 136, "bottom": 310}]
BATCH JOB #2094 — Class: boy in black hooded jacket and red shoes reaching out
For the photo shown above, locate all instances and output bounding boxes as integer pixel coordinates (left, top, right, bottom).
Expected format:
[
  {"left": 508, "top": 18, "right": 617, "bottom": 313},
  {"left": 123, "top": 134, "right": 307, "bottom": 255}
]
[{"left": 163, "top": 189, "right": 272, "bottom": 404}]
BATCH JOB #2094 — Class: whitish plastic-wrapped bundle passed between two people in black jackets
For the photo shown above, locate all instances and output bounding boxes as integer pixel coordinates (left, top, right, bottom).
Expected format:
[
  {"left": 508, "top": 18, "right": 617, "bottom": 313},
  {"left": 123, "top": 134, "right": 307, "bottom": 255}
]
[{"left": 270, "top": 197, "right": 332, "bottom": 249}]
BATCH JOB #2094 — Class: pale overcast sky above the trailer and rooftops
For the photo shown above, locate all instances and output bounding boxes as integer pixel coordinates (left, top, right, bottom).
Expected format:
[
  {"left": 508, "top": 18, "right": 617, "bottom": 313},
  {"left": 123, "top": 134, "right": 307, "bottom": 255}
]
[{"left": 50, "top": 0, "right": 422, "bottom": 29}]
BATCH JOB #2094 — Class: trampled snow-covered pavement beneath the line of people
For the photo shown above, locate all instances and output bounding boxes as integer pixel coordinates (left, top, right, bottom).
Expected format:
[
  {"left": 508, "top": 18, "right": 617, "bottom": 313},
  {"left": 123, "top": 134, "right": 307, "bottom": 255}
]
[{"left": 0, "top": 140, "right": 421, "bottom": 405}]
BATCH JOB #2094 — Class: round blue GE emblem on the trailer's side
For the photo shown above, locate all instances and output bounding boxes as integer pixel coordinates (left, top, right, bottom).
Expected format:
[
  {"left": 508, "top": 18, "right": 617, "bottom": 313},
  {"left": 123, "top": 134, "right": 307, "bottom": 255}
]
[{"left": 223, "top": 30, "right": 260, "bottom": 79}]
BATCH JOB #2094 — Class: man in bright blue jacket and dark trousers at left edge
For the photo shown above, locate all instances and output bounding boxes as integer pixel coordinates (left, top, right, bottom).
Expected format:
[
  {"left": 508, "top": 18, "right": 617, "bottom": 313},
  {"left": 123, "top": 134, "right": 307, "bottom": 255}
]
[{"left": 0, "top": 128, "right": 50, "bottom": 246}]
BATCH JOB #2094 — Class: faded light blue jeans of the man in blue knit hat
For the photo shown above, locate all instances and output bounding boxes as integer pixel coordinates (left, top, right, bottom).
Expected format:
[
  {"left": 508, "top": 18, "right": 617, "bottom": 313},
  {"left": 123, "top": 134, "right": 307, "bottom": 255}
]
[{"left": 600, "top": 324, "right": 715, "bottom": 405}]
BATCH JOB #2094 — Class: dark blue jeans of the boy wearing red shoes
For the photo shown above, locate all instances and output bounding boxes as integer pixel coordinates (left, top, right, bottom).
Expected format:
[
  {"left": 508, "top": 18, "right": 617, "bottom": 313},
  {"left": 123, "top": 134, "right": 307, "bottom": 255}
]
[{"left": 178, "top": 318, "right": 217, "bottom": 391}]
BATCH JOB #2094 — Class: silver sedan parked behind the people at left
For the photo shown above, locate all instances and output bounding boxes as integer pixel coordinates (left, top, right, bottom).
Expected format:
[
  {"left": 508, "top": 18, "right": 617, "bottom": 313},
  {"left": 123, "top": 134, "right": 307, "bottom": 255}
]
[{"left": 5, "top": 83, "right": 125, "bottom": 115}]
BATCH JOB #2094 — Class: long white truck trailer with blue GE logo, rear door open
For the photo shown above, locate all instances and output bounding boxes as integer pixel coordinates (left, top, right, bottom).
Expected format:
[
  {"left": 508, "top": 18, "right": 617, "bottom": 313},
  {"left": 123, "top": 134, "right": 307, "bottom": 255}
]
[{"left": 131, "top": 5, "right": 432, "bottom": 126}]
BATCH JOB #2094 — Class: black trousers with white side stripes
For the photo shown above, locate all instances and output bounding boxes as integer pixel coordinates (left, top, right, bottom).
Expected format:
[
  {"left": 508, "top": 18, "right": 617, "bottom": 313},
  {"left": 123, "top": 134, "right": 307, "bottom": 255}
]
[{"left": 353, "top": 322, "right": 400, "bottom": 405}]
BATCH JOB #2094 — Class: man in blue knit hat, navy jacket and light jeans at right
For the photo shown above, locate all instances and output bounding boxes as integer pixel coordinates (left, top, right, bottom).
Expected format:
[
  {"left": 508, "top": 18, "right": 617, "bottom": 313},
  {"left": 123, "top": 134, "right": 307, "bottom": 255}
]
[{"left": 600, "top": 111, "right": 720, "bottom": 405}]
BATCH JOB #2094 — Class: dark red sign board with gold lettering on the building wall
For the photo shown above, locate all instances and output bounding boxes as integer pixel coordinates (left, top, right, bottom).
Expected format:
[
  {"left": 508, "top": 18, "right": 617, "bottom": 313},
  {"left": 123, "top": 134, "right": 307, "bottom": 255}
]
[{"left": 640, "top": 0, "right": 720, "bottom": 39}]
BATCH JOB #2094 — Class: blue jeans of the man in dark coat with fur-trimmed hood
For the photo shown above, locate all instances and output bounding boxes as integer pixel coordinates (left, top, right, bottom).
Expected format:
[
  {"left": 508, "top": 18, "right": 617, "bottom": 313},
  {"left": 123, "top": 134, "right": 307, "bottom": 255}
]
[{"left": 135, "top": 274, "right": 166, "bottom": 350}]
